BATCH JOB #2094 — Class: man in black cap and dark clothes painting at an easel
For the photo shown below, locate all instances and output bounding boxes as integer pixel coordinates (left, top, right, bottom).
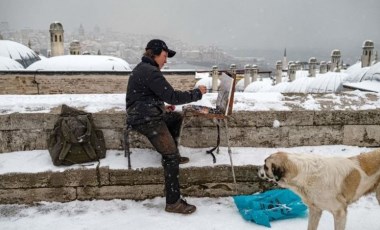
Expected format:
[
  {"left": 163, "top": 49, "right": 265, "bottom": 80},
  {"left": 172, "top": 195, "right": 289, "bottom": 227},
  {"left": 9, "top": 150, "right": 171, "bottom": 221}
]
[{"left": 126, "top": 39, "right": 207, "bottom": 214}]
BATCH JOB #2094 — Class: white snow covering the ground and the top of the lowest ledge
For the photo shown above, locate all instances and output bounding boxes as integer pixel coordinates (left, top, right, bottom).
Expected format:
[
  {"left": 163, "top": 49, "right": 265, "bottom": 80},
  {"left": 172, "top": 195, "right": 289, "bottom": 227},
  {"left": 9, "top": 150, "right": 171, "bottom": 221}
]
[{"left": 0, "top": 145, "right": 380, "bottom": 230}]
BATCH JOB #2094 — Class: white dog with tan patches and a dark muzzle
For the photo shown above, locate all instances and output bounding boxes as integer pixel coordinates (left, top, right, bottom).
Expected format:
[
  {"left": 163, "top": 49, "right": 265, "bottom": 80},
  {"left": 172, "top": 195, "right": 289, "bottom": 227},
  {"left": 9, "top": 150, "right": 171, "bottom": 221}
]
[{"left": 258, "top": 149, "right": 380, "bottom": 230}]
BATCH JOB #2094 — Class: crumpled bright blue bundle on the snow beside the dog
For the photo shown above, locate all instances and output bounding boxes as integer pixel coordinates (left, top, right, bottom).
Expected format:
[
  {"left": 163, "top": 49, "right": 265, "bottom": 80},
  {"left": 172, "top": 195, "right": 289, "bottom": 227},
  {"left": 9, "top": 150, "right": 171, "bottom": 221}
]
[{"left": 233, "top": 189, "right": 307, "bottom": 227}]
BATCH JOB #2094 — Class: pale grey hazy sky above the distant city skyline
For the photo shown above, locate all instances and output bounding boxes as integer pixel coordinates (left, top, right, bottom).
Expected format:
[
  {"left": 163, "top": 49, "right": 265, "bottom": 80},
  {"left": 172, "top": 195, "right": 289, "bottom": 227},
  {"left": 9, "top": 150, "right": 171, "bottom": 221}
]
[{"left": 0, "top": 0, "right": 380, "bottom": 53}]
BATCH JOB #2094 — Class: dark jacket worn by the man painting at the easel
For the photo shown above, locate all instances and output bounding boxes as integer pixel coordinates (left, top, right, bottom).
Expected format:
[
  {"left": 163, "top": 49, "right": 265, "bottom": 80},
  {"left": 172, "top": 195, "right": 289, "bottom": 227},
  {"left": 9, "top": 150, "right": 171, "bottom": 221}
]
[{"left": 126, "top": 56, "right": 202, "bottom": 125}]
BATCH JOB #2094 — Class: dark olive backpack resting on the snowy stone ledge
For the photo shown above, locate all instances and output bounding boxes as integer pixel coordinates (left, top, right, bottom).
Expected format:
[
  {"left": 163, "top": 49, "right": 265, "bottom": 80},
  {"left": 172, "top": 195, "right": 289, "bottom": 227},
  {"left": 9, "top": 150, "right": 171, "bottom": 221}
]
[{"left": 47, "top": 105, "right": 106, "bottom": 166}]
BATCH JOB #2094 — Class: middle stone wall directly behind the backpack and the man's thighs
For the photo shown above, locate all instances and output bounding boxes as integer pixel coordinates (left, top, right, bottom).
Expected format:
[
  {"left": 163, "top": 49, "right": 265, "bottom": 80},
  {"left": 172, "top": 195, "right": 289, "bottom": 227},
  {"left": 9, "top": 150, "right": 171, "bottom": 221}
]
[{"left": 0, "top": 109, "right": 380, "bottom": 153}]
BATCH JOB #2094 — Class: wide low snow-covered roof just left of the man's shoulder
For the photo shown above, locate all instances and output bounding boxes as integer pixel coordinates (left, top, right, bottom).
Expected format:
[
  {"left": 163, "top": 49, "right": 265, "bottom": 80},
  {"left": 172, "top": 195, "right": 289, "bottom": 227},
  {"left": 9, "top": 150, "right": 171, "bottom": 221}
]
[{"left": 27, "top": 55, "right": 131, "bottom": 71}]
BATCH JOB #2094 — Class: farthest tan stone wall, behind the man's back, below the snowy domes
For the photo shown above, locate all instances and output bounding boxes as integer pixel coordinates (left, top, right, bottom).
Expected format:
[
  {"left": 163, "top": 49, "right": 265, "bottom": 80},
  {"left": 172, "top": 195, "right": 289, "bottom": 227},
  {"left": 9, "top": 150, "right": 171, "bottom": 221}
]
[{"left": 0, "top": 71, "right": 196, "bottom": 94}]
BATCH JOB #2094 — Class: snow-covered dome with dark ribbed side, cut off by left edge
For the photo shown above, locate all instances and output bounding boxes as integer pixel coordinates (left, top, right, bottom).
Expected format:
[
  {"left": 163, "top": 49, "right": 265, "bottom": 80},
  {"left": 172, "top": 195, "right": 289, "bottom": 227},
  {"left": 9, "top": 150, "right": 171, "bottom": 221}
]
[{"left": 0, "top": 40, "right": 41, "bottom": 68}]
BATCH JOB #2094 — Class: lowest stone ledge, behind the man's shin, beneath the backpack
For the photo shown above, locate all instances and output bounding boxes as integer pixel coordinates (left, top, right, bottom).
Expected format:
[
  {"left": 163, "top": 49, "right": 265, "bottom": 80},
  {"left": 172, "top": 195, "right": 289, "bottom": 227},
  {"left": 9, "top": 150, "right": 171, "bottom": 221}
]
[{"left": 0, "top": 165, "right": 272, "bottom": 204}]
